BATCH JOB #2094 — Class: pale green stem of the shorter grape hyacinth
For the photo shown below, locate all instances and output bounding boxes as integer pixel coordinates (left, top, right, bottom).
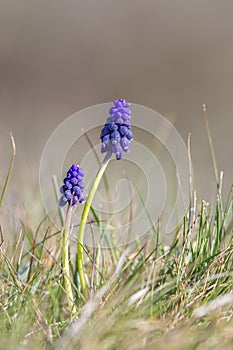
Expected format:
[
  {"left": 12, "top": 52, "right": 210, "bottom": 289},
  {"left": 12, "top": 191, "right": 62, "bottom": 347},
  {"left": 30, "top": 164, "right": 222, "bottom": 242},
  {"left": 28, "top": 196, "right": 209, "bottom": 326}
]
[{"left": 61, "top": 205, "right": 77, "bottom": 314}]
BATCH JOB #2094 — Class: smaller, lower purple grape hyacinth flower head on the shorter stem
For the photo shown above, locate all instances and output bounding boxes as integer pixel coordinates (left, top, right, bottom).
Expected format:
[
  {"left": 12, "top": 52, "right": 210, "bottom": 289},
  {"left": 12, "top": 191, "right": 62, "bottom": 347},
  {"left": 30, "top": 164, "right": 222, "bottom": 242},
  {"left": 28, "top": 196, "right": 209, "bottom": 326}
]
[{"left": 59, "top": 164, "right": 85, "bottom": 207}]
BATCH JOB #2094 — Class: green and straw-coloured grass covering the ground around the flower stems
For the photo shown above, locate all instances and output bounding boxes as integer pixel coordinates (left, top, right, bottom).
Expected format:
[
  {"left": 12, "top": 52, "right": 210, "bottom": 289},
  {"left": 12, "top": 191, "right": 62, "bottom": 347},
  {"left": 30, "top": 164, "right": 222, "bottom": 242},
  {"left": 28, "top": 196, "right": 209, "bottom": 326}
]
[{"left": 0, "top": 109, "right": 233, "bottom": 350}]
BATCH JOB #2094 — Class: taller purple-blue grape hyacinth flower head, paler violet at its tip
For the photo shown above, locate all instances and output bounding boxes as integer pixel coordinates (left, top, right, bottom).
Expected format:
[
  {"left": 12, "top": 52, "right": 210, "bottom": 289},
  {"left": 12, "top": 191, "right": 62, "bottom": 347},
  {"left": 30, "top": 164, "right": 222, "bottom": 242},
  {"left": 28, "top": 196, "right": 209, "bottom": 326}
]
[{"left": 100, "top": 99, "right": 133, "bottom": 160}]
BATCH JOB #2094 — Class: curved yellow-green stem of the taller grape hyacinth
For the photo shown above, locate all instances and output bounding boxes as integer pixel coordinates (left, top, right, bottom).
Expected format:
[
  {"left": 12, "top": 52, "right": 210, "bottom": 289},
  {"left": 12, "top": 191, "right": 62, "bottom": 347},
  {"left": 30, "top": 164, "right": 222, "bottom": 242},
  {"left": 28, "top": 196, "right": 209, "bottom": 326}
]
[{"left": 77, "top": 159, "right": 109, "bottom": 299}]
